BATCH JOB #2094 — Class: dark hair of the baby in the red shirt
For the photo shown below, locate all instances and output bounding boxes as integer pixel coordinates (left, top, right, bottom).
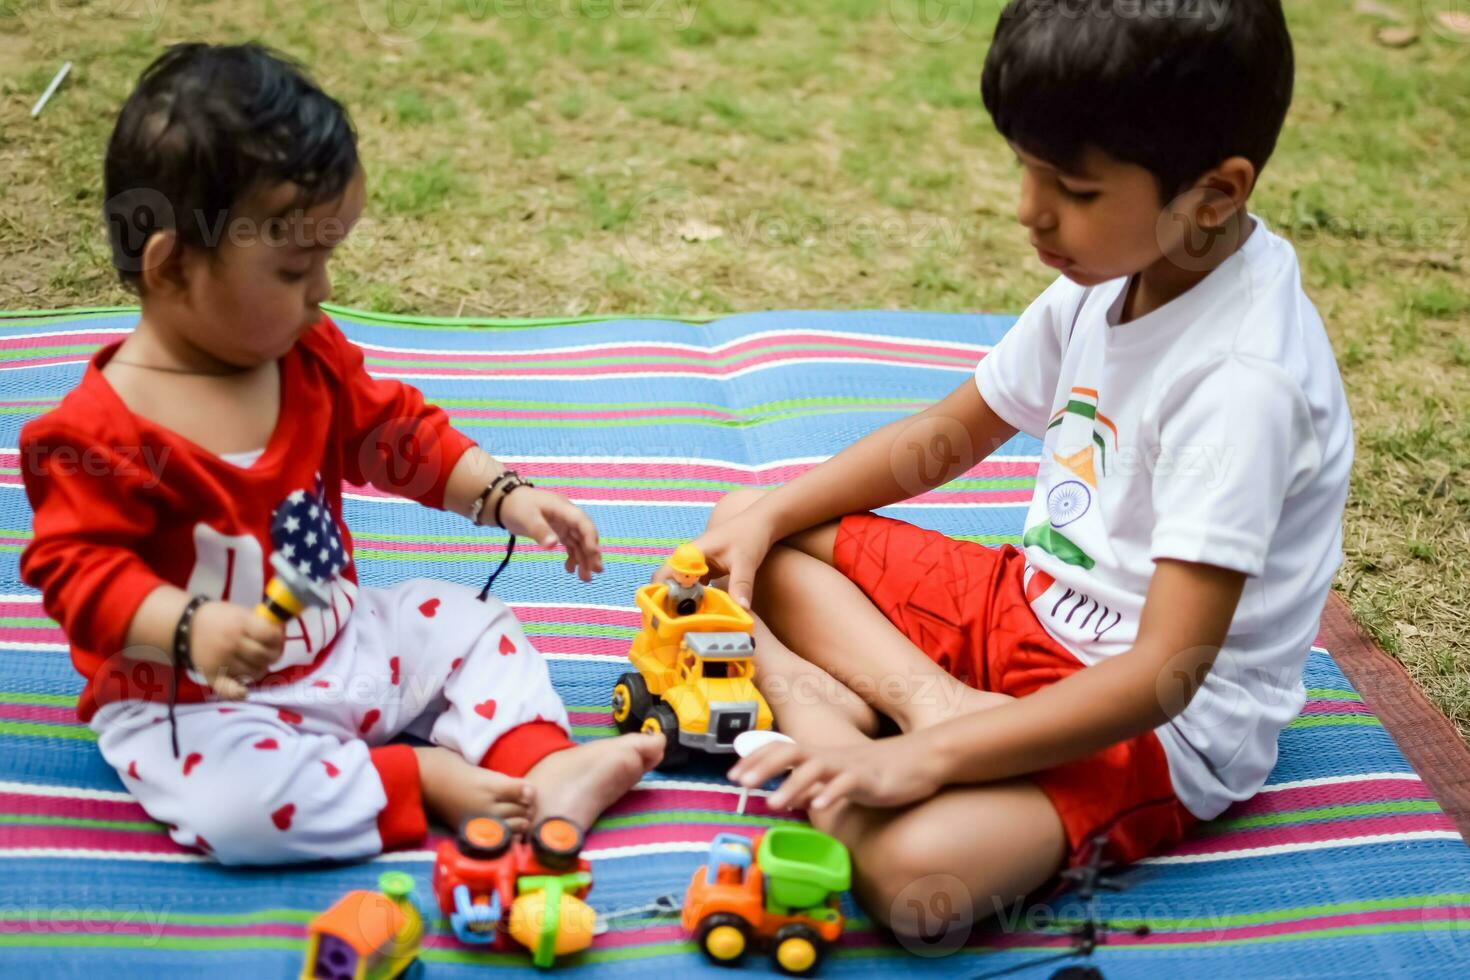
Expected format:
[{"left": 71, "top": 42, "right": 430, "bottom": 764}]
[{"left": 103, "top": 44, "right": 357, "bottom": 289}]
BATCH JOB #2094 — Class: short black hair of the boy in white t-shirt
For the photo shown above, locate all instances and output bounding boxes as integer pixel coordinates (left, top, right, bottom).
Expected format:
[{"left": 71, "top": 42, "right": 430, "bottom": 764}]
[{"left": 980, "top": 0, "right": 1292, "bottom": 201}]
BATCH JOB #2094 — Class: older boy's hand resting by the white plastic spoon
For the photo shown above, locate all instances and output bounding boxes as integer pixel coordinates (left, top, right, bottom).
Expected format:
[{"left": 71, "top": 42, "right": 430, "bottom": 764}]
[{"left": 729, "top": 735, "right": 944, "bottom": 810}]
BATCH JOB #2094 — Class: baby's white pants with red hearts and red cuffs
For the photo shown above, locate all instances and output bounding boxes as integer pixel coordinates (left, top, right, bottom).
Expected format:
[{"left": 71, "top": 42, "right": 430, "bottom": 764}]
[{"left": 91, "top": 579, "right": 570, "bottom": 864}]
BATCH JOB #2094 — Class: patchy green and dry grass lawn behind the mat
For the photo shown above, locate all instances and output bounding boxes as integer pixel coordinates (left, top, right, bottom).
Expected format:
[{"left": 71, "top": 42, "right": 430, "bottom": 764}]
[{"left": 0, "top": 0, "right": 1470, "bottom": 736}]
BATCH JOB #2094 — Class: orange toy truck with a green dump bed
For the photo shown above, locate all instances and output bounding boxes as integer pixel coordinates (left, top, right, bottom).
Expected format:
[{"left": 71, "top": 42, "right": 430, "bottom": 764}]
[{"left": 682, "top": 827, "right": 853, "bottom": 977}]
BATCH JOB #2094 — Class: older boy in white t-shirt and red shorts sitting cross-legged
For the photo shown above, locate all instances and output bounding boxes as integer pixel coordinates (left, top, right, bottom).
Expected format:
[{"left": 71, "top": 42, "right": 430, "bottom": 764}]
[{"left": 673, "top": 0, "right": 1352, "bottom": 933}]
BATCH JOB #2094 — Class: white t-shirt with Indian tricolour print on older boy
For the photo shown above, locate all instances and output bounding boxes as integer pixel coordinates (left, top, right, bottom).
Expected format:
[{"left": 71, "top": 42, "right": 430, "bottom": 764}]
[{"left": 975, "top": 217, "right": 1352, "bottom": 820}]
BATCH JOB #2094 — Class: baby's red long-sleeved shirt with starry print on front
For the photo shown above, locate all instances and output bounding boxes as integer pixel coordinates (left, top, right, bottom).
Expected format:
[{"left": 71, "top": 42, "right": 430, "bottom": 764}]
[{"left": 21, "top": 316, "right": 475, "bottom": 721}]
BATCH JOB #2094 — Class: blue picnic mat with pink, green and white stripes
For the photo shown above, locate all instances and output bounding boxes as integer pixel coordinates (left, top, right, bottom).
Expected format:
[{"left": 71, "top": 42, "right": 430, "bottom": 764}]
[{"left": 0, "top": 302, "right": 1470, "bottom": 979}]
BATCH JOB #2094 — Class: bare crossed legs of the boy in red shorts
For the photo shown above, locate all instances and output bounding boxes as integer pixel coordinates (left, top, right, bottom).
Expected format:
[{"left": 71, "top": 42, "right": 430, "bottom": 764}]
[{"left": 711, "top": 494, "right": 1066, "bottom": 942}]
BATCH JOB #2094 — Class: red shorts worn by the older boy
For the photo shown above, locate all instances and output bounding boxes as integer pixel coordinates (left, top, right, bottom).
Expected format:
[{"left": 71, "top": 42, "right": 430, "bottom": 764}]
[{"left": 832, "top": 514, "right": 1198, "bottom": 867}]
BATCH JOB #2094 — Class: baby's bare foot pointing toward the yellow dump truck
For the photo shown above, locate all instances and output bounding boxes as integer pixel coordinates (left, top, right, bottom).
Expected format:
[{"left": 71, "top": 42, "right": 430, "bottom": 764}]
[{"left": 526, "top": 732, "right": 663, "bottom": 829}]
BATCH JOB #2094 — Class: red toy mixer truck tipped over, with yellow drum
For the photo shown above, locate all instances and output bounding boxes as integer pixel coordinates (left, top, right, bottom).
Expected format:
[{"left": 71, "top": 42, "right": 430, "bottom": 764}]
[{"left": 434, "top": 817, "right": 595, "bottom": 968}]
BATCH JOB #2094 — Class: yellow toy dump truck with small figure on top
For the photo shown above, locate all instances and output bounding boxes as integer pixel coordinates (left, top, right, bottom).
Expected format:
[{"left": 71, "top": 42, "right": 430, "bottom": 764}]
[{"left": 612, "top": 545, "right": 772, "bottom": 771}]
